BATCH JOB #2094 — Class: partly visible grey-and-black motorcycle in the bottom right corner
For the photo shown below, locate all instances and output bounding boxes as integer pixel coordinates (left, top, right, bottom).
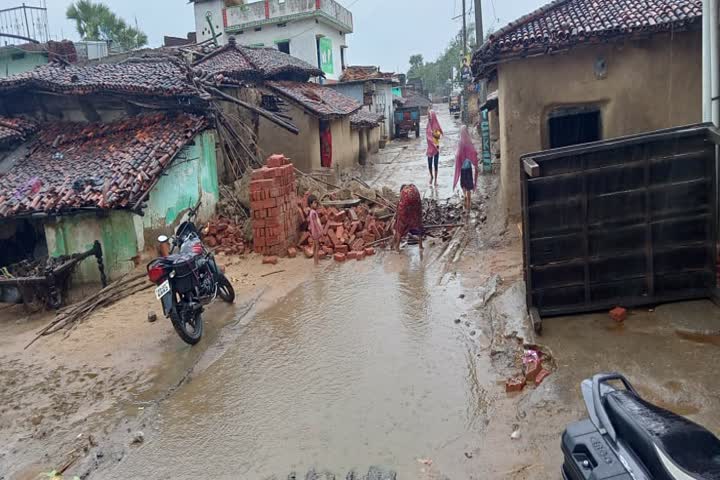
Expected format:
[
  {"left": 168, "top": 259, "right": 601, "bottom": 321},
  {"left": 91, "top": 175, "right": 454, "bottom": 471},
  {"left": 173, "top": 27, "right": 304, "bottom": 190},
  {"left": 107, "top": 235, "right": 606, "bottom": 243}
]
[{"left": 562, "top": 373, "right": 720, "bottom": 480}]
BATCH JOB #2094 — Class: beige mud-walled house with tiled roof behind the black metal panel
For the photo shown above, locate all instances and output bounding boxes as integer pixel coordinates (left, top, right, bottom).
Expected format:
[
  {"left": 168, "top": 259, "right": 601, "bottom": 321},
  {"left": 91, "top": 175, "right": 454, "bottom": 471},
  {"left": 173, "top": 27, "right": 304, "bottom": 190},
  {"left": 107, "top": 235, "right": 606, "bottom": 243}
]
[{"left": 473, "top": 0, "right": 702, "bottom": 217}]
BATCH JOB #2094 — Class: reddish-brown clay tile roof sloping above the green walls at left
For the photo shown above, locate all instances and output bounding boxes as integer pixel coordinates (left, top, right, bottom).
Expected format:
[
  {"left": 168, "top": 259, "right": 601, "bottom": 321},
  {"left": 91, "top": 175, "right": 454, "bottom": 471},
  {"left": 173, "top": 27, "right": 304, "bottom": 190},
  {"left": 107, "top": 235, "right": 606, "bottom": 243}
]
[{"left": 0, "top": 113, "right": 207, "bottom": 217}]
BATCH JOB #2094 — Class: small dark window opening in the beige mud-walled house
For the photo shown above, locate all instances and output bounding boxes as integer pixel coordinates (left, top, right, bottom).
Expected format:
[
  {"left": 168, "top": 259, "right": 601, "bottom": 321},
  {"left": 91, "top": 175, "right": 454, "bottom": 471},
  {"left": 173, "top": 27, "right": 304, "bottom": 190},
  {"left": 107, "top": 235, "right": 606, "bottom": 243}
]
[{"left": 548, "top": 107, "right": 602, "bottom": 148}]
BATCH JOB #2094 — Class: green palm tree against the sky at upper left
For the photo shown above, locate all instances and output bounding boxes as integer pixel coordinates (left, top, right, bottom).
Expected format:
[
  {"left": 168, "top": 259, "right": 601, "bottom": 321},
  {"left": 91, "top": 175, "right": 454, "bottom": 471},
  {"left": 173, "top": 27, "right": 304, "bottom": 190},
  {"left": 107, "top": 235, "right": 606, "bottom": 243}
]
[{"left": 65, "top": 0, "right": 148, "bottom": 50}]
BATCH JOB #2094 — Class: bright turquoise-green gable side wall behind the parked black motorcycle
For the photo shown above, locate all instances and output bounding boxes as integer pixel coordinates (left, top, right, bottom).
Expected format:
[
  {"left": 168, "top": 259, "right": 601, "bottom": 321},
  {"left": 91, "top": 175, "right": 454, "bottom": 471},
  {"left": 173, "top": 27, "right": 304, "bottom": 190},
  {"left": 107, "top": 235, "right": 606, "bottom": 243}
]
[{"left": 143, "top": 130, "right": 220, "bottom": 245}]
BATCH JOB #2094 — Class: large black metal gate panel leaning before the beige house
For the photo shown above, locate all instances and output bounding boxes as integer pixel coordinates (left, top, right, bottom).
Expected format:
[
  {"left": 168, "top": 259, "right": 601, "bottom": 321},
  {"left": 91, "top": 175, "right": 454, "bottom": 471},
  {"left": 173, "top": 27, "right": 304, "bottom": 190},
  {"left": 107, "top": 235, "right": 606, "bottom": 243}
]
[{"left": 520, "top": 124, "right": 720, "bottom": 331}]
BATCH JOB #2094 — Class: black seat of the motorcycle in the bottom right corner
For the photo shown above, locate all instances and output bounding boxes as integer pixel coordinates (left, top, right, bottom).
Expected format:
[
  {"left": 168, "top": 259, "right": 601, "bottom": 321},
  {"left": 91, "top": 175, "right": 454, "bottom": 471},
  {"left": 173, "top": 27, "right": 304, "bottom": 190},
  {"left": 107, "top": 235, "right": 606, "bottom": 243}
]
[{"left": 603, "top": 390, "right": 720, "bottom": 480}]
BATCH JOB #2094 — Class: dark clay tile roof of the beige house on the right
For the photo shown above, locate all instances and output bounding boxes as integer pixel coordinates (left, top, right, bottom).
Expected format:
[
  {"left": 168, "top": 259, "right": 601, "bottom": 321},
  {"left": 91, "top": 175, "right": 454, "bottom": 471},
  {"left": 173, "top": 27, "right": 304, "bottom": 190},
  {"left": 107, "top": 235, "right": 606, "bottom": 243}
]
[{"left": 473, "top": 0, "right": 702, "bottom": 75}]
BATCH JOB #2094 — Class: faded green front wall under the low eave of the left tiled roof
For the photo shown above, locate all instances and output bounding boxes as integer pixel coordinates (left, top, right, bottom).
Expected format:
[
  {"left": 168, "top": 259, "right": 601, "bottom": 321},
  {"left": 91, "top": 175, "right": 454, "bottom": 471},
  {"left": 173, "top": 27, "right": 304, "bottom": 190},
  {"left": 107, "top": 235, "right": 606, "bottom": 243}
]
[{"left": 45, "top": 210, "right": 138, "bottom": 283}]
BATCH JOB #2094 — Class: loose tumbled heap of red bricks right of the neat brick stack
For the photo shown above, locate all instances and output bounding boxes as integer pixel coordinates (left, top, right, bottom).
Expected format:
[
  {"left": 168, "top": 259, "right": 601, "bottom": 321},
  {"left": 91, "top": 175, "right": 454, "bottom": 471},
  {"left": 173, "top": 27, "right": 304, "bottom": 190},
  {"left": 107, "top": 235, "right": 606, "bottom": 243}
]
[{"left": 298, "top": 195, "right": 390, "bottom": 262}]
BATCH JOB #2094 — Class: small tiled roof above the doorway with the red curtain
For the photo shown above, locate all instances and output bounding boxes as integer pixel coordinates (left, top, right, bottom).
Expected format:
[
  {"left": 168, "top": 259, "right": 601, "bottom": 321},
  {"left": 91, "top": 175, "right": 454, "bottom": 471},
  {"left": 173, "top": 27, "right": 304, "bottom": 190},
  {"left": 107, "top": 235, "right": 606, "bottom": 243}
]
[{"left": 267, "top": 81, "right": 362, "bottom": 118}]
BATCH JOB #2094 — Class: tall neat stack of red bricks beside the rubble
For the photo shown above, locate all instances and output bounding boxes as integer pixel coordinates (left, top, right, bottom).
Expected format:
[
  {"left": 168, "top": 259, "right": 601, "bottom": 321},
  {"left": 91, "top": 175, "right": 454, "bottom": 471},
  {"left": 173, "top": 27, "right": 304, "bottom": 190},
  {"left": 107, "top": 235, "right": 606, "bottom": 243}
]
[{"left": 250, "top": 155, "right": 299, "bottom": 256}]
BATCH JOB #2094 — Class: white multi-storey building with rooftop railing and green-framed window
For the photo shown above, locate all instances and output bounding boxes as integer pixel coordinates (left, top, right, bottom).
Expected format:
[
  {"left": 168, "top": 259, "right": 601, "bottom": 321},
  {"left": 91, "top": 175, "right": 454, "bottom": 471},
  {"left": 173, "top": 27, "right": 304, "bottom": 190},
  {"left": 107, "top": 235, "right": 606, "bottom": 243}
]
[{"left": 194, "top": 0, "right": 353, "bottom": 80}]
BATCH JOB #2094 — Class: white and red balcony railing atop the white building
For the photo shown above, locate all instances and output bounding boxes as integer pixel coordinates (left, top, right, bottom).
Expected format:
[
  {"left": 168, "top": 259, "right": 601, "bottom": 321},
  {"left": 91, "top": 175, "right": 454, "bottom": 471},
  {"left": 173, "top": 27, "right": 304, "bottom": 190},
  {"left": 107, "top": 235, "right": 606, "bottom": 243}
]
[{"left": 225, "top": 0, "right": 353, "bottom": 32}]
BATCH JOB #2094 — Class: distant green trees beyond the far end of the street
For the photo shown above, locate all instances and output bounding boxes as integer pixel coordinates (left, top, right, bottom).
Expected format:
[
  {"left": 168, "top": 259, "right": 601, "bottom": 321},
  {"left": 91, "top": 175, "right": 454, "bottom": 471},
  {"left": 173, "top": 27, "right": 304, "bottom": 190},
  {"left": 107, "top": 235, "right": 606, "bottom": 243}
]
[{"left": 407, "top": 24, "right": 476, "bottom": 95}]
